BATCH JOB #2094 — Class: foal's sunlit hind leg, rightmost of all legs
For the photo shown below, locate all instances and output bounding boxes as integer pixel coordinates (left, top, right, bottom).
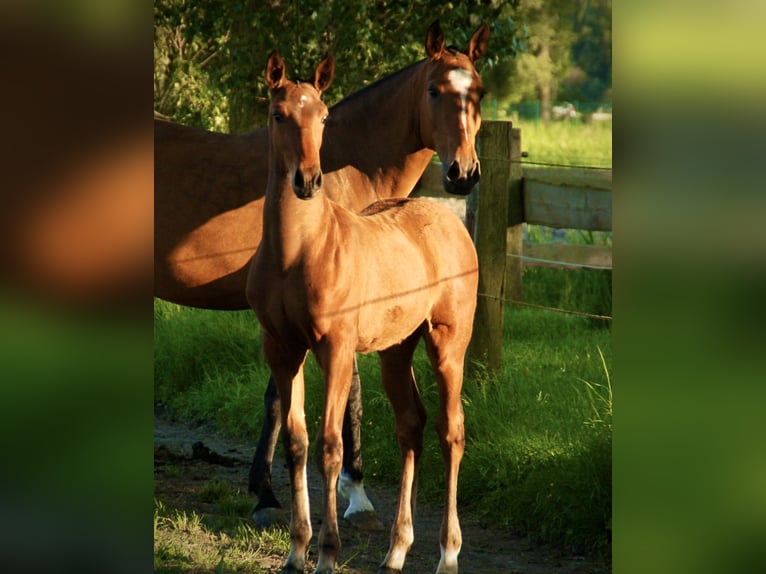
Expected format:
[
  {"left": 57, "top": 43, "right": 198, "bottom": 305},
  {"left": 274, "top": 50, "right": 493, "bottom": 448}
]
[{"left": 426, "top": 325, "right": 470, "bottom": 574}]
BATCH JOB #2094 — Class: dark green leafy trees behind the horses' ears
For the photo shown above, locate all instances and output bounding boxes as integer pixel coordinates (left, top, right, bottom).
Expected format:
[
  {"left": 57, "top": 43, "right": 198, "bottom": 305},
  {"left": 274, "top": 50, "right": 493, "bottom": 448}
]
[{"left": 154, "top": 0, "right": 520, "bottom": 132}]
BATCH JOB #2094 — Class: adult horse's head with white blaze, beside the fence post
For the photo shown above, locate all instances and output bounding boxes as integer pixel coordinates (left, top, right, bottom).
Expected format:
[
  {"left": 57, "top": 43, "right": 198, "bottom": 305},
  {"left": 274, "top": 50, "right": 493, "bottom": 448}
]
[{"left": 420, "top": 20, "right": 489, "bottom": 195}]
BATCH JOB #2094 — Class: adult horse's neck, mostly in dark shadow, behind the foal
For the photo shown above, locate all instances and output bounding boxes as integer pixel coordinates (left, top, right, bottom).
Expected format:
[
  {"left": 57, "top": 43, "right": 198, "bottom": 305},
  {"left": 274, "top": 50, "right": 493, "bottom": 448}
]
[{"left": 322, "top": 64, "right": 433, "bottom": 198}]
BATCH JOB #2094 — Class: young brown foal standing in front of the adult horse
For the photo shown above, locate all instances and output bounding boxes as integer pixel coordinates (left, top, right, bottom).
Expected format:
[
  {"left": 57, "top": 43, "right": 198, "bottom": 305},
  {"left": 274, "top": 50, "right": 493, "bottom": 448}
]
[{"left": 247, "top": 52, "right": 478, "bottom": 573}]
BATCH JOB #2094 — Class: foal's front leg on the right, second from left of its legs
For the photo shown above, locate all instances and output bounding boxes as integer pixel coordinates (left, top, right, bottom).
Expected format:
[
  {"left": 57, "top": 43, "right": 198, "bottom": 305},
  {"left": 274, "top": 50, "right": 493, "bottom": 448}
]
[{"left": 316, "top": 344, "right": 353, "bottom": 574}]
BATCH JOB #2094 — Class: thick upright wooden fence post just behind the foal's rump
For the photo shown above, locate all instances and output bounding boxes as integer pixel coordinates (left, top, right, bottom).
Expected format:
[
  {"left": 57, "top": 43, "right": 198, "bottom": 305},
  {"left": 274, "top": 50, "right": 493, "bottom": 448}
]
[{"left": 470, "top": 121, "right": 512, "bottom": 371}]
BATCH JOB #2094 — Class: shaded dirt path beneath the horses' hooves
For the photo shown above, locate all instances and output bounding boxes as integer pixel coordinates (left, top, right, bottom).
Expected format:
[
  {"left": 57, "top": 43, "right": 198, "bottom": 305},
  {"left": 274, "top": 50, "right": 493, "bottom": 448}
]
[{"left": 154, "top": 414, "right": 611, "bottom": 574}]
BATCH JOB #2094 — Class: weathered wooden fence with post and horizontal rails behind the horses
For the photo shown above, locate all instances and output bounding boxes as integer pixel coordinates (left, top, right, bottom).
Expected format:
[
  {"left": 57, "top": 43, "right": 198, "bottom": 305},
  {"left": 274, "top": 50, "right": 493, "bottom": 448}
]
[{"left": 414, "top": 120, "right": 612, "bottom": 370}]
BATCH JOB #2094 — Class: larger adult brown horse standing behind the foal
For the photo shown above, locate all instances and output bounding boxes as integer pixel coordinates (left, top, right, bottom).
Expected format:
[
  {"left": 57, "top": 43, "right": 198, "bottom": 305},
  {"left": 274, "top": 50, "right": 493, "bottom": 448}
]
[{"left": 155, "top": 21, "right": 489, "bottom": 523}]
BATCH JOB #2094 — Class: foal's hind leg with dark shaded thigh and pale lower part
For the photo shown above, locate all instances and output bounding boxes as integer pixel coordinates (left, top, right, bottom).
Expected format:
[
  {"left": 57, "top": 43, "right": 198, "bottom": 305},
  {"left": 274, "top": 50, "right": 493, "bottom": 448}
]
[{"left": 378, "top": 332, "right": 426, "bottom": 572}]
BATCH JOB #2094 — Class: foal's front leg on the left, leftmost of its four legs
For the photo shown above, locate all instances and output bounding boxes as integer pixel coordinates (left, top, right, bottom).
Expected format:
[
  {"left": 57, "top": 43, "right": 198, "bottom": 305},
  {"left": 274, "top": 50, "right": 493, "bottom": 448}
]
[{"left": 263, "top": 332, "right": 313, "bottom": 573}]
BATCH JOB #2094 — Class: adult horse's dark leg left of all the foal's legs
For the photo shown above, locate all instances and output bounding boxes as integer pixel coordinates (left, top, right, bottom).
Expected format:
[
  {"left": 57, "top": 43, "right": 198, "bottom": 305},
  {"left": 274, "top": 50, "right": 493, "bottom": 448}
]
[{"left": 248, "top": 375, "right": 285, "bottom": 527}]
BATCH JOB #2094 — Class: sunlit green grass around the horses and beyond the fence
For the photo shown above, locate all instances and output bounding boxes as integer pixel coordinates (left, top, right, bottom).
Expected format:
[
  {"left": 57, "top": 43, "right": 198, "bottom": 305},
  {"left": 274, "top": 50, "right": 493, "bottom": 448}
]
[{"left": 154, "top": 119, "right": 612, "bottom": 564}]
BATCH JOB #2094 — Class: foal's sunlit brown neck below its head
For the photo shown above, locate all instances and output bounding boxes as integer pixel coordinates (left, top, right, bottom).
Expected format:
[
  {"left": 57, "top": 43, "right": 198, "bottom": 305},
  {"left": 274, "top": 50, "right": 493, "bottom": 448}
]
[{"left": 262, "top": 168, "right": 331, "bottom": 269}]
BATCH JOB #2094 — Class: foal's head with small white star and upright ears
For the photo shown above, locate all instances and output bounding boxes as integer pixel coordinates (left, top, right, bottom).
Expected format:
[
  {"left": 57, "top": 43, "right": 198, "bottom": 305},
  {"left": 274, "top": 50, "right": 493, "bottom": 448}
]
[{"left": 266, "top": 50, "right": 335, "bottom": 199}]
